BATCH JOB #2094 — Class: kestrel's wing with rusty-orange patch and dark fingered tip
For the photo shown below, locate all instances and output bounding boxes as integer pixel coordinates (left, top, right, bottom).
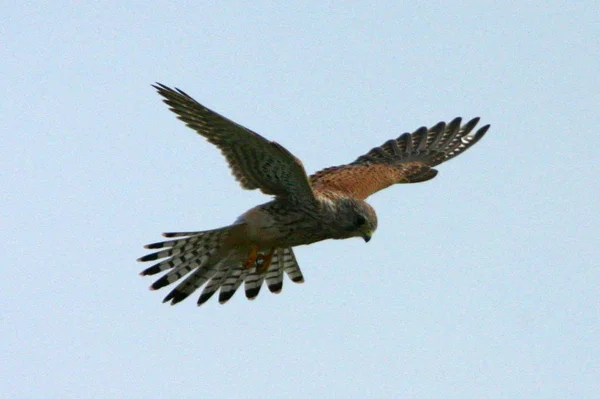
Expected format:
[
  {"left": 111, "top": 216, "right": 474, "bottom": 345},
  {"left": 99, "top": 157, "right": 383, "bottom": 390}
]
[{"left": 310, "top": 118, "right": 490, "bottom": 199}]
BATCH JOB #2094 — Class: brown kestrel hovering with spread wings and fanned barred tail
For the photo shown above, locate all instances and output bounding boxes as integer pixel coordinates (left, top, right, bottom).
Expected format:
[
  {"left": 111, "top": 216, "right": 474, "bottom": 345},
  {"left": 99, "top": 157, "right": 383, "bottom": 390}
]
[{"left": 138, "top": 83, "right": 490, "bottom": 306}]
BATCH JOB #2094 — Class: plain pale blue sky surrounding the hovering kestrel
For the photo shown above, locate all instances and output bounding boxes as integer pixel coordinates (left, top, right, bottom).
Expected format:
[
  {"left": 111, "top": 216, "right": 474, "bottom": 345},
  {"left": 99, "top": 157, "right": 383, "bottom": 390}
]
[{"left": 0, "top": 1, "right": 600, "bottom": 399}]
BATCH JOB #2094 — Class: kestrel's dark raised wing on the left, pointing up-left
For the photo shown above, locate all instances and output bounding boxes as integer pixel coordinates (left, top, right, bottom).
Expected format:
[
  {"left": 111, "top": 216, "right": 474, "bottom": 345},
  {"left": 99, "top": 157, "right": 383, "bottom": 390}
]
[{"left": 153, "top": 83, "right": 314, "bottom": 201}]
